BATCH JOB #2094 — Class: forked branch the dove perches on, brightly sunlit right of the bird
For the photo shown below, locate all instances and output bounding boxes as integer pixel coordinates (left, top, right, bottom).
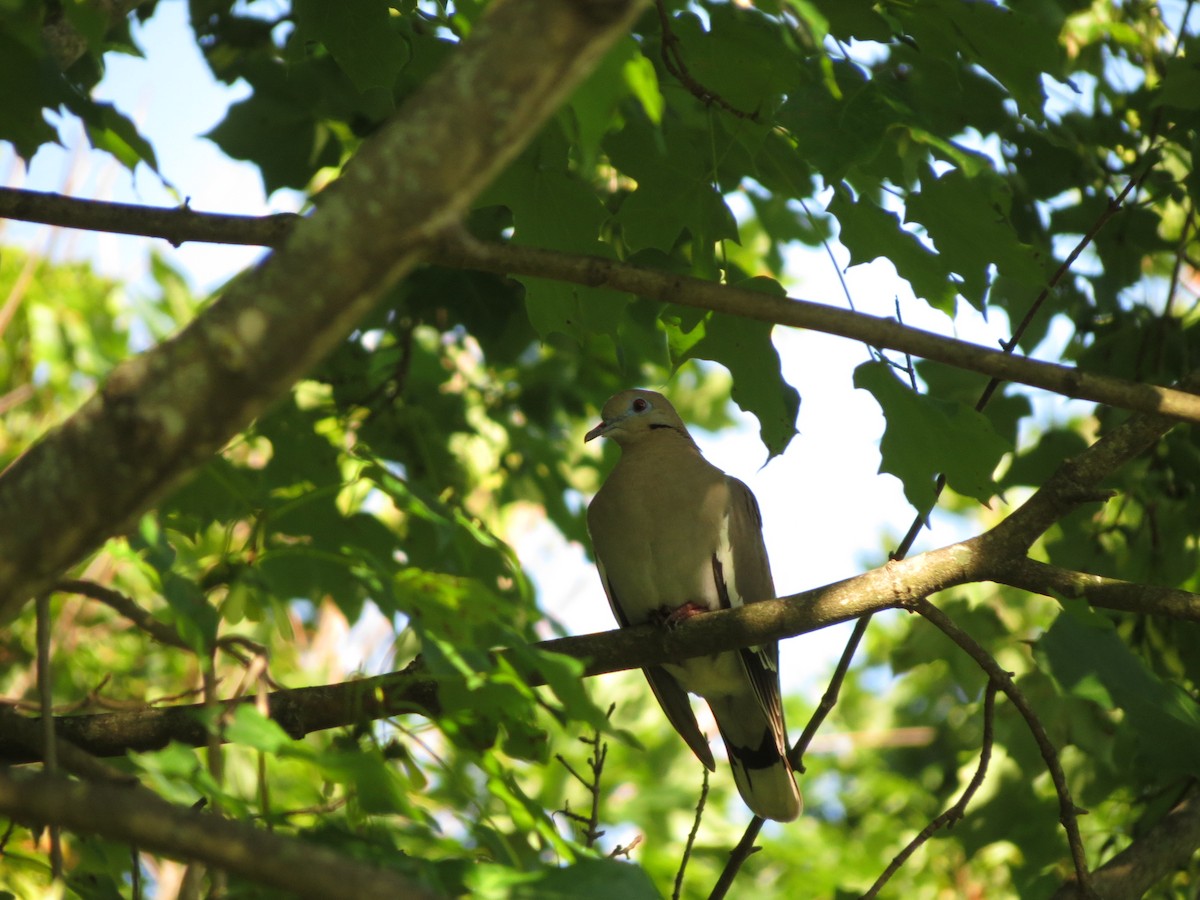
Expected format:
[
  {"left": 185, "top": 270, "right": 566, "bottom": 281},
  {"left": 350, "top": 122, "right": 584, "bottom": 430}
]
[{"left": 0, "top": 355, "right": 1200, "bottom": 762}]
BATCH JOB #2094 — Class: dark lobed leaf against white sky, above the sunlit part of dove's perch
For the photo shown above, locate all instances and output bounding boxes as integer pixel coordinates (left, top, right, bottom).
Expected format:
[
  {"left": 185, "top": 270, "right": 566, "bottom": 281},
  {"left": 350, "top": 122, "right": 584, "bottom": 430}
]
[{"left": 854, "top": 362, "right": 1012, "bottom": 515}]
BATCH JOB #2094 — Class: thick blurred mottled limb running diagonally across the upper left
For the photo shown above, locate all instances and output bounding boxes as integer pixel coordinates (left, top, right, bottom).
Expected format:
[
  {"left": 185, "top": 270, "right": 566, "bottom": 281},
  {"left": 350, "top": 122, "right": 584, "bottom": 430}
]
[{"left": 0, "top": 0, "right": 641, "bottom": 620}]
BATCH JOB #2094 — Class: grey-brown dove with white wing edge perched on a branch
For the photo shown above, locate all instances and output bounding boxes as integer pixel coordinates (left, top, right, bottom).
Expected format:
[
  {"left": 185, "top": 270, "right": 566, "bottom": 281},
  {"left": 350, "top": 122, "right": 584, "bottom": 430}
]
[{"left": 583, "top": 390, "right": 803, "bottom": 822}]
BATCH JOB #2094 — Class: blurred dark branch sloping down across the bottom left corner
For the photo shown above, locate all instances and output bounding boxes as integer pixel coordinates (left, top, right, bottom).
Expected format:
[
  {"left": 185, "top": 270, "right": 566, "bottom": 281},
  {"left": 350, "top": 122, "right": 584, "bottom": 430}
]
[{"left": 0, "top": 768, "right": 433, "bottom": 900}]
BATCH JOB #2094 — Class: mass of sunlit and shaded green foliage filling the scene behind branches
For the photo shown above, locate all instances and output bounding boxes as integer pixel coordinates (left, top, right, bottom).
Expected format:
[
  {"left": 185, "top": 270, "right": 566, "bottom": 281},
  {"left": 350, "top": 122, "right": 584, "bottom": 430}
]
[{"left": 0, "top": 0, "right": 1200, "bottom": 898}]
